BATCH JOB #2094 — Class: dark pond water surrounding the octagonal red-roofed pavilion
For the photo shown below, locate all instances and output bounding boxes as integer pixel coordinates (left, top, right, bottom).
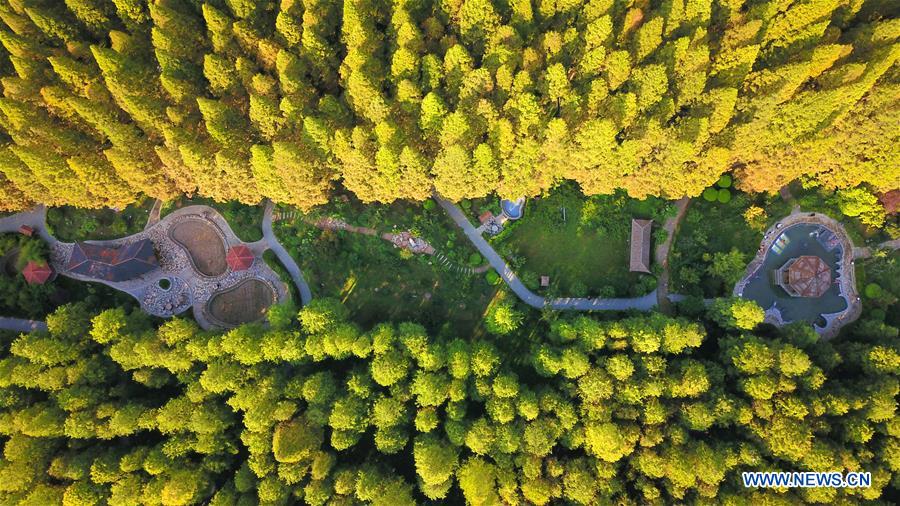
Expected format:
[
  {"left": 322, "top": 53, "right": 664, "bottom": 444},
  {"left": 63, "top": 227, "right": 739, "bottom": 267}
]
[{"left": 741, "top": 223, "right": 847, "bottom": 326}]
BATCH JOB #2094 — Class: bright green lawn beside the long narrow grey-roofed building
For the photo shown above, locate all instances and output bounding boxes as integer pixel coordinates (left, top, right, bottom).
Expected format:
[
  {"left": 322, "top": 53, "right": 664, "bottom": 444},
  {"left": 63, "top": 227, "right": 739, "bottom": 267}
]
[{"left": 493, "top": 184, "right": 668, "bottom": 297}]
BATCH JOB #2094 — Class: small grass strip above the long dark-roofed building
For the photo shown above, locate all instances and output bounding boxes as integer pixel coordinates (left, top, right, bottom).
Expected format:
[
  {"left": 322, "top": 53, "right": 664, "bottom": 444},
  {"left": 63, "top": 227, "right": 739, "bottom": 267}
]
[{"left": 47, "top": 197, "right": 154, "bottom": 242}]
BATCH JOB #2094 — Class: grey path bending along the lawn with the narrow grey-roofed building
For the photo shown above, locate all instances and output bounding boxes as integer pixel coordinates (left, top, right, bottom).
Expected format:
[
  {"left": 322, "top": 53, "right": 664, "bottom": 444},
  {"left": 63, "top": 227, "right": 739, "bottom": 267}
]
[{"left": 434, "top": 194, "right": 682, "bottom": 311}]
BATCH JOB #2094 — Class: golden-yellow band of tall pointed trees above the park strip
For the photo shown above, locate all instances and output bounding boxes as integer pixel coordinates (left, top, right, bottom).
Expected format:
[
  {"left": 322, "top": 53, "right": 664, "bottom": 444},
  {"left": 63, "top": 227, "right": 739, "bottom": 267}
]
[{"left": 0, "top": 0, "right": 900, "bottom": 210}]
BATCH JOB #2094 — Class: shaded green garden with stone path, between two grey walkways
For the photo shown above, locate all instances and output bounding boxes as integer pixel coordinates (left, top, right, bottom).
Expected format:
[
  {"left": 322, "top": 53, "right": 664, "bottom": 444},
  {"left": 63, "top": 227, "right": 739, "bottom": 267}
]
[{"left": 274, "top": 198, "right": 500, "bottom": 335}]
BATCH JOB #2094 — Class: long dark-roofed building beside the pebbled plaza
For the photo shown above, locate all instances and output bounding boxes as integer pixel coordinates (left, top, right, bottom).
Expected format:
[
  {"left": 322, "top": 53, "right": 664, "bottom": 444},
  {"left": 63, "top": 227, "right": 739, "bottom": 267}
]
[{"left": 66, "top": 239, "right": 159, "bottom": 282}]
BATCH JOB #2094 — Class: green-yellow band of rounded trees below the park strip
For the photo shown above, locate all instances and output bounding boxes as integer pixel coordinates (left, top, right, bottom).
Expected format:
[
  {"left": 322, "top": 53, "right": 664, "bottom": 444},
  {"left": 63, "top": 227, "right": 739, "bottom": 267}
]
[{"left": 0, "top": 299, "right": 900, "bottom": 506}]
